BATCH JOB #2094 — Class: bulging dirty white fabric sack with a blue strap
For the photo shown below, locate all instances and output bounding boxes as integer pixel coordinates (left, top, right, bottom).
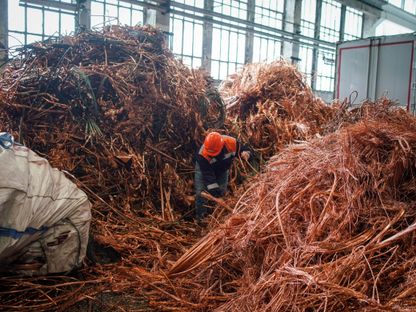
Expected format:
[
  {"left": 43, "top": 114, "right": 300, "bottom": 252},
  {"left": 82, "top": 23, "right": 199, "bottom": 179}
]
[{"left": 0, "top": 145, "right": 91, "bottom": 275}]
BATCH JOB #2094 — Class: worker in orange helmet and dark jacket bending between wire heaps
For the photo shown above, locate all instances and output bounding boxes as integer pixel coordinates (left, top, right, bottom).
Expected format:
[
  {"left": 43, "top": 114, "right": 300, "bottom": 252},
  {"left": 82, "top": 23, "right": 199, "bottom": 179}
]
[{"left": 195, "top": 132, "right": 251, "bottom": 220}]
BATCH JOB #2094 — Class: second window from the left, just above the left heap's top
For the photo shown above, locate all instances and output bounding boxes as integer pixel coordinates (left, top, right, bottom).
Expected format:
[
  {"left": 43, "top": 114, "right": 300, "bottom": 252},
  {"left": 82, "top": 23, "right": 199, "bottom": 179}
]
[{"left": 91, "top": 0, "right": 144, "bottom": 28}]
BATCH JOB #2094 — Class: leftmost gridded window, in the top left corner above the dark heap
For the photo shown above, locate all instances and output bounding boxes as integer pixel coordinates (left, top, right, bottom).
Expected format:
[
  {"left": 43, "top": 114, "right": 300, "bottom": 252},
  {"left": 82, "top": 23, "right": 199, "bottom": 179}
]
[{"left": 8, "top": 0, "right": 75, "bottom": 54}]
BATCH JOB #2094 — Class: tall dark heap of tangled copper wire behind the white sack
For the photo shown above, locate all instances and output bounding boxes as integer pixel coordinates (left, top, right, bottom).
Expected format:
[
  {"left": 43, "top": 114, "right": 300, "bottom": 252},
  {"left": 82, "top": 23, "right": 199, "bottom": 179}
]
[{"left": 0, "top": 27, "right": 222, "bottom": 220}]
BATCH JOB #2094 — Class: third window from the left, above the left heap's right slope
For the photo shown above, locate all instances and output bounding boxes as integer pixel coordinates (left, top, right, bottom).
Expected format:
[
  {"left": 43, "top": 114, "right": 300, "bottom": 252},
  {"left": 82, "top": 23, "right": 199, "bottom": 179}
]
[{"left": 169, "top": 0, "right": 204, "bottom": 68}]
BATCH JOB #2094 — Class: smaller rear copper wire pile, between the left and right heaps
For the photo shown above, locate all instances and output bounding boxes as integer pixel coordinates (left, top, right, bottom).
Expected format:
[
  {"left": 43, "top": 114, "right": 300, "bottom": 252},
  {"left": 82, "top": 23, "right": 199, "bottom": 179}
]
[{"left": 219, "top": 61, "right": 335, "bottom": 160}]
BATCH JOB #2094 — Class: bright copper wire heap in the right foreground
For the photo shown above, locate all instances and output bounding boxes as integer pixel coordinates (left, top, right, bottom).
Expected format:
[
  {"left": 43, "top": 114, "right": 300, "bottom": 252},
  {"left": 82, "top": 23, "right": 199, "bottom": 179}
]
[{"left": 169, "top": 103, "right": 416, "bottom": 311}]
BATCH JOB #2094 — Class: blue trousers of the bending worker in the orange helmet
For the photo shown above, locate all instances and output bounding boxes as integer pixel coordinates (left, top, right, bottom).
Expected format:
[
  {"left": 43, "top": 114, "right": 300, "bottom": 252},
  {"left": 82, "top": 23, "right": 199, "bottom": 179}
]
[{"left": 194, "top": 163, "right": 229, "bottom": 220}]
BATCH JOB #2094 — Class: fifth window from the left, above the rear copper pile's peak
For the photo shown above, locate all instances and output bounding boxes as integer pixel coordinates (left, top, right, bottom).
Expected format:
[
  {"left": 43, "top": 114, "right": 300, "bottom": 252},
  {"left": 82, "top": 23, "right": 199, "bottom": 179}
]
[{"left": 253, "top": 0, "right": 284, "bottom": 62}]
